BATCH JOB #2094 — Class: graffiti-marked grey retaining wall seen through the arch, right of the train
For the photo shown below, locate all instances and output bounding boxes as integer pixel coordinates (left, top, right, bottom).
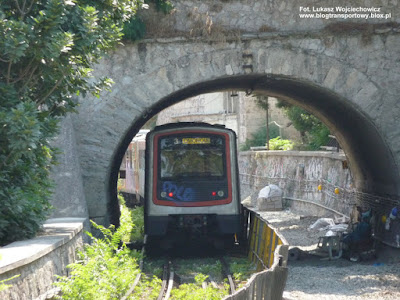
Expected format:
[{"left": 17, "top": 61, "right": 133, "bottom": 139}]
[{"left": 239, "top": 151, "right": 354, "bottom": 215}]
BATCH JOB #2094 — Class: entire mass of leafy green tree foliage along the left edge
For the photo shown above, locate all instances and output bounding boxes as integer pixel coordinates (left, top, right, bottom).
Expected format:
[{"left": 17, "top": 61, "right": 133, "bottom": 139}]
[{"left": 0, "top": 0, "right": 172, "bottom": 245}]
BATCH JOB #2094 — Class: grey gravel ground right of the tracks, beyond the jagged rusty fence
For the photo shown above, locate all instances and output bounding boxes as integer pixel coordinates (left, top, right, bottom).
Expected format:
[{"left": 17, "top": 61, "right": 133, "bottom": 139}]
[{"left": 261, "top": 211, "right": 400, "bottom": 300}]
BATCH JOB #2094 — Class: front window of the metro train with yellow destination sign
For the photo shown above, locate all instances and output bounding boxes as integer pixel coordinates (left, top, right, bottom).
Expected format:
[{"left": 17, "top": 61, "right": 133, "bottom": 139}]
[{"left": 159, "top": 134, "right": 225, "bottom": 179}]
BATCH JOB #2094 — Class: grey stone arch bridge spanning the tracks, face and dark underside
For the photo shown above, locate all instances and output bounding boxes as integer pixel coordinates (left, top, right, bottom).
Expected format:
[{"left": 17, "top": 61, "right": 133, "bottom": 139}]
[{"left": 49, "top": 0, "right": 400, "bottom": 232}]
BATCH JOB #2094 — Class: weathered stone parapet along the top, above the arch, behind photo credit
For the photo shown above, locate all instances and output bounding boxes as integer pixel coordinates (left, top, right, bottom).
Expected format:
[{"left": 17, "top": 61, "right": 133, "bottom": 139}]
[{"left": 144, "top": 0, "right": 399, "bottom": 37}]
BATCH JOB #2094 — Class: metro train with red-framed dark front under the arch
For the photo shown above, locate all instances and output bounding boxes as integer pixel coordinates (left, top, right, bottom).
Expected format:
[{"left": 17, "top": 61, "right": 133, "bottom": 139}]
[{"left": 123, "top": 122, "right": 244, "bottom": 248}]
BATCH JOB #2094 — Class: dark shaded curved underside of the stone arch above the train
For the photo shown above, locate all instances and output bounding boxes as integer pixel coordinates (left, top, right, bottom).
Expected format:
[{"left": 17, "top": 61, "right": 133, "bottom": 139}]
[{"left": 104, "top": 74, "right": 399, "bottom": 225}]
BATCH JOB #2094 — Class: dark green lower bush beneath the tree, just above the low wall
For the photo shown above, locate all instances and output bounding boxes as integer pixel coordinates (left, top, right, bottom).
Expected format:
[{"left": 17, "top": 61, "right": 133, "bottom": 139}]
[{"left": 0, "top": 101, "right": 57, "bottom": 245}]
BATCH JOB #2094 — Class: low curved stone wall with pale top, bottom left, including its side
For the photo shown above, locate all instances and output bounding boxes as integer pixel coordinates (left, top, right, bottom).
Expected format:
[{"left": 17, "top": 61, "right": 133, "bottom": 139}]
[{"left": 0, "top": 218, "right": 85, "bottom": 300}]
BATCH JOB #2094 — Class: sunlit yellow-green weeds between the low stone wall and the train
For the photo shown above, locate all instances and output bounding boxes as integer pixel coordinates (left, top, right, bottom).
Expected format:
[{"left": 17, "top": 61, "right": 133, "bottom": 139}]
[{"left": 55, "top": 195, "right": 162, "bottom": 300}]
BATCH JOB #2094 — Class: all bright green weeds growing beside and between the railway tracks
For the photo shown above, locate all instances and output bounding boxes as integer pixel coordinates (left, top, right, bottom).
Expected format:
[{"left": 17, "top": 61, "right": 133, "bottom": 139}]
[{"left": 54, "top": 196, "right": 255, "bottom": 300}]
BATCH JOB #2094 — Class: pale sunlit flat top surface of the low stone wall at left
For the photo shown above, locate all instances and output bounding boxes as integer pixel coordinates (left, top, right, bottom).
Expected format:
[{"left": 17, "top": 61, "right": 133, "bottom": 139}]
[{"left": 0, "top": 218, "right": 86, "bottom": 275}]
